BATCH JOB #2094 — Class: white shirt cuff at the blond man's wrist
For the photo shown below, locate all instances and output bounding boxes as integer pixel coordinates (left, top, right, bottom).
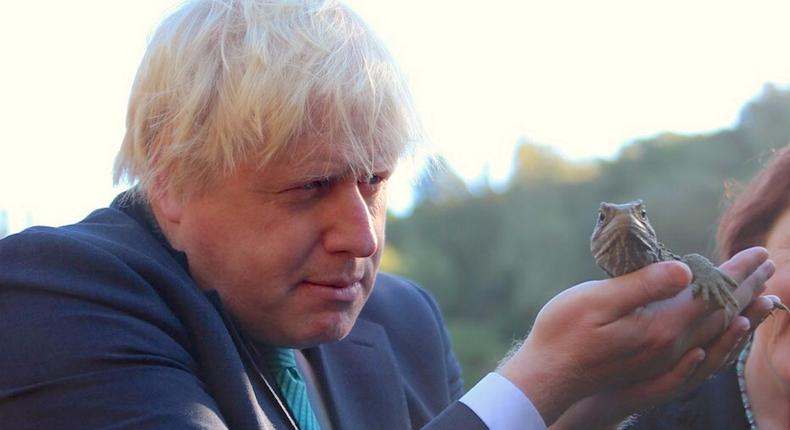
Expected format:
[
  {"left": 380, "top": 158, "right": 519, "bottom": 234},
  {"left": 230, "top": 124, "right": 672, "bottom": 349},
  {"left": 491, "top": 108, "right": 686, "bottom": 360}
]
[{"left": 461, "top": 372, "right": 546, "bottom": 430}]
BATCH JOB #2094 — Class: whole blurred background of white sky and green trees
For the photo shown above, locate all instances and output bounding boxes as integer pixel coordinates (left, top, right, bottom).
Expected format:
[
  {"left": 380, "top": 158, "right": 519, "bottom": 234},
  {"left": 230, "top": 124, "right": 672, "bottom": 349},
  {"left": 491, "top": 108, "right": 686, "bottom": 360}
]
[{"left": 0, "top": 0, "right": 790, "bottom": 384}]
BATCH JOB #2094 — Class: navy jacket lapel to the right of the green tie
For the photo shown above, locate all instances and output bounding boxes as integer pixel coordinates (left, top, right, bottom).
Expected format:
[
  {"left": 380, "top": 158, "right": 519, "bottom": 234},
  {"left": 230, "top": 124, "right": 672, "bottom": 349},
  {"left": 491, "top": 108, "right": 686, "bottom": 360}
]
[{"left": 306, "top": 318, "right": 411, "bottom": 430}]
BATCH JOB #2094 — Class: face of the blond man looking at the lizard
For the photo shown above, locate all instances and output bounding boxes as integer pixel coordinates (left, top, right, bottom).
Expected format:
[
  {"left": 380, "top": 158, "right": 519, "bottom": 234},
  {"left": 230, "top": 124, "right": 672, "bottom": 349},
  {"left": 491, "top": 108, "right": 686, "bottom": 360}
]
[{"left": 165, "top": 138, "right": 392, "bottom": 347}]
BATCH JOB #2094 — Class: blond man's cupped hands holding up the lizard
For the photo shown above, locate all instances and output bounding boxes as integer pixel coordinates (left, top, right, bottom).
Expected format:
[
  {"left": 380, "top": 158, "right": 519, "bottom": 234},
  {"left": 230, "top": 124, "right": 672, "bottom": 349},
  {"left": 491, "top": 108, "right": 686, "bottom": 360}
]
[{"left": 499, "top": 248, "right": 774, "bottom": 427}]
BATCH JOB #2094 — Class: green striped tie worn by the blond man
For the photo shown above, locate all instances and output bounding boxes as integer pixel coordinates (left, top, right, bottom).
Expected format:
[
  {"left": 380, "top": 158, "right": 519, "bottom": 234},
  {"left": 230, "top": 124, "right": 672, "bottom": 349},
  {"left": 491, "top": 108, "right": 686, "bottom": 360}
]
[{"left": 262, "top": 348, "right": 321, "bottom": 430}]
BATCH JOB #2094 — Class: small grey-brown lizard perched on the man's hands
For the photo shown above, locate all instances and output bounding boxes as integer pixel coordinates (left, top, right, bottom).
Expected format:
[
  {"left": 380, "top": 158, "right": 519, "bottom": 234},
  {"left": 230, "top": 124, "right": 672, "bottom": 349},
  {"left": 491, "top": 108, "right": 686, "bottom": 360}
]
[{"left": 590, "top": 200, "right": 740, "bottom": 316}]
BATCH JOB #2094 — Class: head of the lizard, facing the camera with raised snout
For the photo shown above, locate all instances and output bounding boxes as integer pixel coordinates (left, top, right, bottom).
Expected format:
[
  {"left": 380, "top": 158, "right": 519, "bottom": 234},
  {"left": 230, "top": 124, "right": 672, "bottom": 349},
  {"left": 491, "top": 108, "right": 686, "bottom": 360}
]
[{"left": 590, "top": 200, "right": 660, "bottom": 276}]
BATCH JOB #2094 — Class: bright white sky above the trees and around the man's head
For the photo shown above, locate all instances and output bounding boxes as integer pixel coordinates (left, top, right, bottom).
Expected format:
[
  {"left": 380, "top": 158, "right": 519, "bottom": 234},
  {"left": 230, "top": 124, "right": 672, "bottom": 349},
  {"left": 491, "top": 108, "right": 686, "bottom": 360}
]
[{"left": 0, "top": 0, "right": 790, "bottom": 235}]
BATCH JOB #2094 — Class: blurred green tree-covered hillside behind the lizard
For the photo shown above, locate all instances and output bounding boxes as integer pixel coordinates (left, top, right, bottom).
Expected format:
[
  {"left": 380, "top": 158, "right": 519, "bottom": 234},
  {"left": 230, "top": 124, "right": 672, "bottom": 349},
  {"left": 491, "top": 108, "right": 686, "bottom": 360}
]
[{"left": 387, "top": 85, "right": 790, "bottom": 384}]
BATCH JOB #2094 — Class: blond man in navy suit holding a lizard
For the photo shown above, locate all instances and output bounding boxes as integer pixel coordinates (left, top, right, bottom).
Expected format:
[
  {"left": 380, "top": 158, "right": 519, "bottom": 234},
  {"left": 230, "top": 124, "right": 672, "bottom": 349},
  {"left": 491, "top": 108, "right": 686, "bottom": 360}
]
[{"left": 0, "top": 0, "right": 772, "bottom": 430}]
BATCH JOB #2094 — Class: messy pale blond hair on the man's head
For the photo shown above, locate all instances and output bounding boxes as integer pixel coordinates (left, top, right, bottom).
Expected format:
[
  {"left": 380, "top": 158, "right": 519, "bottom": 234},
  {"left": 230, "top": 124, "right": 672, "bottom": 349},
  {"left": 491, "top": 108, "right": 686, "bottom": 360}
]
[{"left": 115, "top": 0, "right": 418, "bottom": 198}]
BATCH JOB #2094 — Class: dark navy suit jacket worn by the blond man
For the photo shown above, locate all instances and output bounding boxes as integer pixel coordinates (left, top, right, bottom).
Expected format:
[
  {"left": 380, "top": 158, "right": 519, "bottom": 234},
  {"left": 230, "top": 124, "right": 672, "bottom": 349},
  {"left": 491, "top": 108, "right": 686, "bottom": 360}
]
[{"left": 0, "top": 199, "right": 485, "bottom": 430}]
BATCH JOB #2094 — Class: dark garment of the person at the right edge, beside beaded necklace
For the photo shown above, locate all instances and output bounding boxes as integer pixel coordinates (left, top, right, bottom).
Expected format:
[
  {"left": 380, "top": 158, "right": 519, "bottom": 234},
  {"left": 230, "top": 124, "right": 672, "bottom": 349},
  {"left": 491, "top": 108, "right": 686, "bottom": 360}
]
[{"left": 626, "top": 366, "right": 749, "bottom": 430}]
